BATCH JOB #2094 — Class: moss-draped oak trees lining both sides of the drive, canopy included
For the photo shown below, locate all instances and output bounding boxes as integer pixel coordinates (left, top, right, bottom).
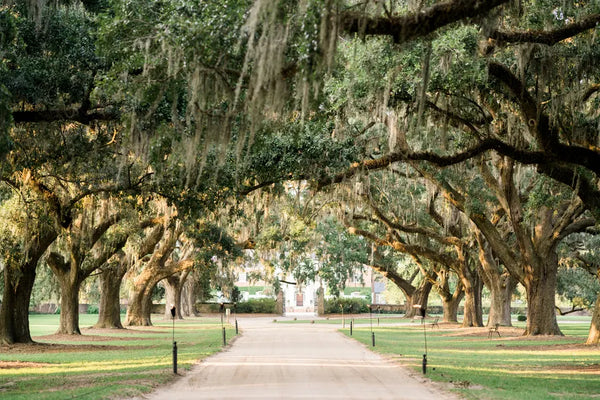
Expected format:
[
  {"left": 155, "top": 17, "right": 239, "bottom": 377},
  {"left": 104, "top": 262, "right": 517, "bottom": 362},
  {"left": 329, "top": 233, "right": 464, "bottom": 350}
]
[{"left": 0, "top": 0, "right": 600, "bottom": 343}]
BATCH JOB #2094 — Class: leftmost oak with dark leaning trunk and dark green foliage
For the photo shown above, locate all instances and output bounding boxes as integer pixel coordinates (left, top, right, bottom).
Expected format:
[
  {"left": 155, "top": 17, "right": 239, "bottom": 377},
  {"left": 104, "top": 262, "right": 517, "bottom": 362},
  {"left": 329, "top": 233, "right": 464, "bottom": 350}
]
[{"left": 0, "top": 2, "right": 127, "bottom": 342}]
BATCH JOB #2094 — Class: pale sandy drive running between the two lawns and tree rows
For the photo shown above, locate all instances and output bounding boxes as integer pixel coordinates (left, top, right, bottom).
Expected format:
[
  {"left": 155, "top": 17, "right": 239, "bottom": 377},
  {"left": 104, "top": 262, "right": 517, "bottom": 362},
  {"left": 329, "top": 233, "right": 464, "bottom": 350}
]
[{"left": 135, "top": 318, "right": 457, "bottom": 400}]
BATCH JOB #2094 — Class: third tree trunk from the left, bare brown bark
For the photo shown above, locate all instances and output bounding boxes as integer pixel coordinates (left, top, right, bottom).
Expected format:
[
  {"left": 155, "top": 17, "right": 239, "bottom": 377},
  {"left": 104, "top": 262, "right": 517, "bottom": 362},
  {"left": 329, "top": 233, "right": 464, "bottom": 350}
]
[{"left": 94, "top": 262, "right": 127, "bottom": 329}]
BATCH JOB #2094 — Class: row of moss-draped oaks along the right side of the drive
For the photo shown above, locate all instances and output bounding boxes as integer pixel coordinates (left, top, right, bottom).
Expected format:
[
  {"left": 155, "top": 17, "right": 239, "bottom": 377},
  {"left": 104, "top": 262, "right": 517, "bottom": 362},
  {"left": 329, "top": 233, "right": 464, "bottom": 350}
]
[{"left": 225, "top": 1, "right": 600, "bottom": 343}]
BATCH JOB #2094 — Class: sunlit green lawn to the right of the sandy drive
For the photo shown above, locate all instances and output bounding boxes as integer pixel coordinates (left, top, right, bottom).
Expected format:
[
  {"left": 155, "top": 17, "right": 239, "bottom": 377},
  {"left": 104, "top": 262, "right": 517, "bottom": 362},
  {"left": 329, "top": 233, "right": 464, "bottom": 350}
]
[{"left": 342, "top": 318, "right": 600, "bottom": 400}]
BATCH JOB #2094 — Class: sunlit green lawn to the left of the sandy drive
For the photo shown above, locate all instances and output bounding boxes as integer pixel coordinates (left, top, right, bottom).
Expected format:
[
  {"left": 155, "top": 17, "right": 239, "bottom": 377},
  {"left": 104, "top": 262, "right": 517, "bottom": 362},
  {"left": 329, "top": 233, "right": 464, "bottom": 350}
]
[{"left": 0, "top": 314, "right": 235, "bottom": 400}]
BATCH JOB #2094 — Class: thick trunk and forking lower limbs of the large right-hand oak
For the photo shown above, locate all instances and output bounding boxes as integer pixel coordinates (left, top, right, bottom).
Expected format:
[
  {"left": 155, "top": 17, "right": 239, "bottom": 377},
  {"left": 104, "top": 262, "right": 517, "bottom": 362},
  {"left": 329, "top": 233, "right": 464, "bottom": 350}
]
[{"left": 424, "top": 158, "right": 594, "bottom": 335}]
